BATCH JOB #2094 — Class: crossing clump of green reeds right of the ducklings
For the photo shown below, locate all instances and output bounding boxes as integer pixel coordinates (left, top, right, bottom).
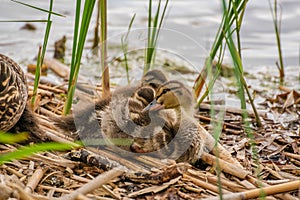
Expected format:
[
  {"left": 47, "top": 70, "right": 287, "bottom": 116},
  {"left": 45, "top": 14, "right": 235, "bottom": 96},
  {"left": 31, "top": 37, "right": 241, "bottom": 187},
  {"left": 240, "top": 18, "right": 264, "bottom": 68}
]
[{"left": 194, "top": 0, "right": 261, "bottom": 126}]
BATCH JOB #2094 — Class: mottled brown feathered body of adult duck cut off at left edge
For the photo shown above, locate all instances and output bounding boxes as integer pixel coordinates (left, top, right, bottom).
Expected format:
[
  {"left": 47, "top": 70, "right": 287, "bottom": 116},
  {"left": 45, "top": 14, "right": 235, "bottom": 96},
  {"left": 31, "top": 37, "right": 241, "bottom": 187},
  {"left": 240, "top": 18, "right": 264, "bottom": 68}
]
[{"left": 0, "top": 54, "right": 46, "bottom": 141}]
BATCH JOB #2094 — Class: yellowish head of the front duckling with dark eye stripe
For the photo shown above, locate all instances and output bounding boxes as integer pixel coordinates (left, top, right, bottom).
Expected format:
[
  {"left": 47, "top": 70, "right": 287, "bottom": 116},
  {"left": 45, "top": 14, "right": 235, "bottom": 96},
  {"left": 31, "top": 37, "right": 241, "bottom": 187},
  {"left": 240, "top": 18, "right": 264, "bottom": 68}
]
[{"left": 144, "top": 80, "right": 193, "bottom": 112}]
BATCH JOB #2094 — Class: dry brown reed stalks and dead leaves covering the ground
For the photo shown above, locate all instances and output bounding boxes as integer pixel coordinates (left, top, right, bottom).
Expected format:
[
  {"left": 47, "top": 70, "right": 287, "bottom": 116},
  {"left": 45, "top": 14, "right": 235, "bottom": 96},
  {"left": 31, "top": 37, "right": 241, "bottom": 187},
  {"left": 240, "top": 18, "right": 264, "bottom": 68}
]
[{"left": 0, "top": 65, "right": 300, "bottom": 200}]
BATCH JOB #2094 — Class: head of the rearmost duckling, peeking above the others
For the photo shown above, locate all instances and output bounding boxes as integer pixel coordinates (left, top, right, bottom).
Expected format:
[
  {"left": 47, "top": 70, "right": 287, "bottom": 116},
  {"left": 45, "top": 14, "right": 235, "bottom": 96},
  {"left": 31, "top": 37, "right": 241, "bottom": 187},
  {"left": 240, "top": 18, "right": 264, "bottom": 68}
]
[{"left": 142, "top": 69, "right": 168, "bottom": 90}]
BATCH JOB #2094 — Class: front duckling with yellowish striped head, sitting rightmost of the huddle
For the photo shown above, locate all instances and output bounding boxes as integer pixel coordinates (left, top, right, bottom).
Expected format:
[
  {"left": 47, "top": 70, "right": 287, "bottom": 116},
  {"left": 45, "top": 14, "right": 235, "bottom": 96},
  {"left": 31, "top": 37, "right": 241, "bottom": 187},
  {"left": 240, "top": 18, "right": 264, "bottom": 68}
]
[{"left": 131, "top": 80, "right": 205, "bottom": 164}]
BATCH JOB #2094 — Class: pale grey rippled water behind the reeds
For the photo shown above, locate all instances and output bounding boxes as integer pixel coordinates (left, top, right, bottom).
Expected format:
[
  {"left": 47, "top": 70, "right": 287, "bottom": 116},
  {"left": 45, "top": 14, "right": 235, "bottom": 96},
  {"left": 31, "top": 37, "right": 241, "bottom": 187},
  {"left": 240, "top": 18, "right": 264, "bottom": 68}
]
[{"left": 0, "top": 0, "right": 300, "bottom": 85}]
